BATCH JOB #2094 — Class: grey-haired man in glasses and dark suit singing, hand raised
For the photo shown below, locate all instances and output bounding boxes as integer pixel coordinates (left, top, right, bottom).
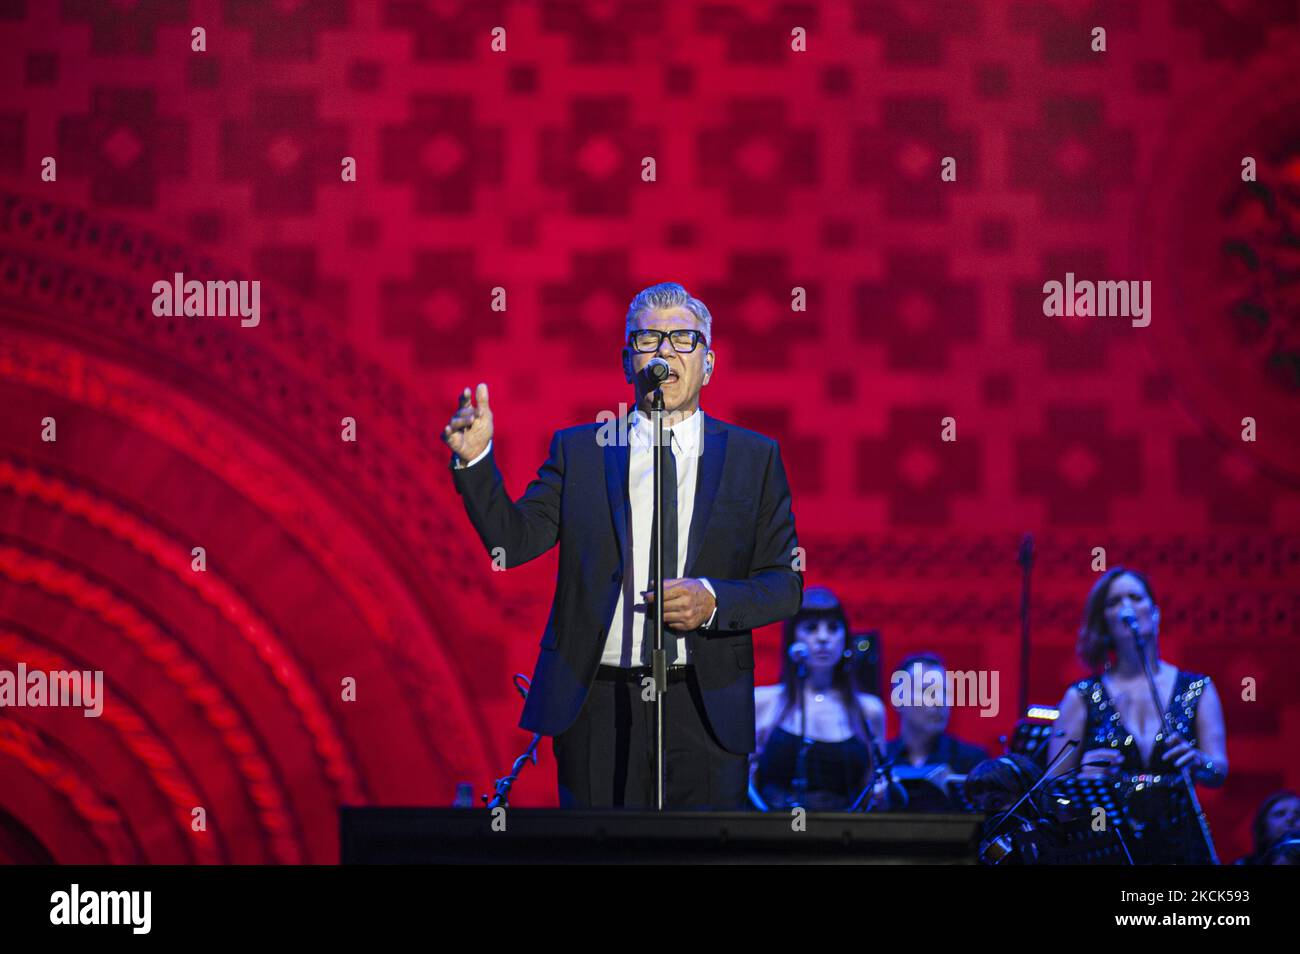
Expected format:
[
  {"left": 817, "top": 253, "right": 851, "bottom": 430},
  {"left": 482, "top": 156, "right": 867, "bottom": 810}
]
[{"left": 443, "top": 282, "right": 803, "bottom": 808}]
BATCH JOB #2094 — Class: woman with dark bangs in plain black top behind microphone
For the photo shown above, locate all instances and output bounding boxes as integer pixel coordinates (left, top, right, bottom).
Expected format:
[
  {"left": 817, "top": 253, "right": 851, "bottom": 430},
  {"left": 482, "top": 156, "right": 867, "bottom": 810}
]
[{"left": 750, "top": 586, "right": 885, "bottom": 811}]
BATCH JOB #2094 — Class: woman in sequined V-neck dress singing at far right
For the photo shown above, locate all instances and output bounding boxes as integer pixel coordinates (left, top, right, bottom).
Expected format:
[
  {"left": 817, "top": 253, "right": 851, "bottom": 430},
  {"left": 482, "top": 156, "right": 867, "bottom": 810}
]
[{"left": 1048, "top": 567, "right": 1227, "bottom": 864}]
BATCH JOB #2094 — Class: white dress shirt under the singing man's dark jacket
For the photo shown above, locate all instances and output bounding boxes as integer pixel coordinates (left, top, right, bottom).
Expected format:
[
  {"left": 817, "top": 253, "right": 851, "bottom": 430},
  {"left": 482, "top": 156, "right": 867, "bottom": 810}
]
[{"left": 455, "top": 409, "right": 718, "bottom": 667}]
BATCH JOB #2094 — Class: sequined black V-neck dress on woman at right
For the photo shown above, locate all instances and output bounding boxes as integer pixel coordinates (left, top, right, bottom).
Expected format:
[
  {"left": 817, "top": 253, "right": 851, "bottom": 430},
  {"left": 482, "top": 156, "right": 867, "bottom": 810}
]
[{"left": 1074, "top": 669, "right": 1210, "bottom": 864}]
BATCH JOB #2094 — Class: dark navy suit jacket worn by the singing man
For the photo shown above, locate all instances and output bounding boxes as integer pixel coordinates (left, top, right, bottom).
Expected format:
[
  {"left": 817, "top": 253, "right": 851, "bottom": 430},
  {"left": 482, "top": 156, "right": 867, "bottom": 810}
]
[{"left": 451, "top": 411, "right": 803, "bottom": 753}]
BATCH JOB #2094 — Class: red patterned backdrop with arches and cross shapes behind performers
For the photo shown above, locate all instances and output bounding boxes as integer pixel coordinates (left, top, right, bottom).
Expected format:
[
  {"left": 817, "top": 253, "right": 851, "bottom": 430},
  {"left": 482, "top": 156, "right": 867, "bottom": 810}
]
[{"left": 0, "top": 0, "right": 1300, "bottom": 863}]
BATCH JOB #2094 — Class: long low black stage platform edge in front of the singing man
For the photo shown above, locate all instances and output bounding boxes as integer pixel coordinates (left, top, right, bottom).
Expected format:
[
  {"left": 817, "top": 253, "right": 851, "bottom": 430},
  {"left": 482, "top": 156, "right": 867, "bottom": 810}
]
[{"left": 339, "top": 808, "right": 983, "bottom": 864}]
